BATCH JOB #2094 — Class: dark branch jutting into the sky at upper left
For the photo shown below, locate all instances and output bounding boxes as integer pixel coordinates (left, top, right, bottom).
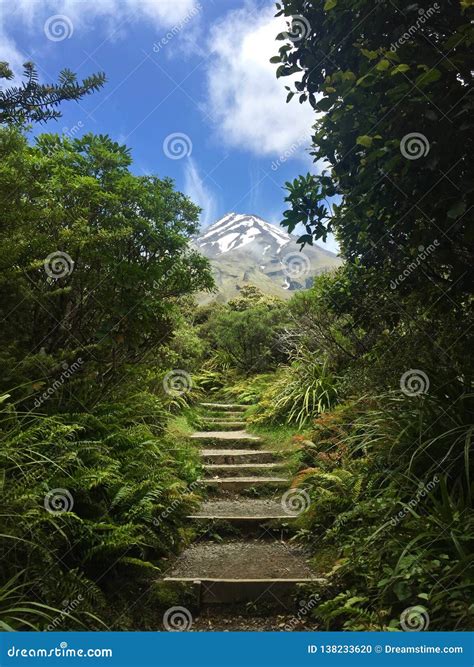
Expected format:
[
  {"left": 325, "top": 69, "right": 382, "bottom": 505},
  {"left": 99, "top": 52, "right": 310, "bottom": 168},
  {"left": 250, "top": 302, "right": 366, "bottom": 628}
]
[{"left": 0, "top": 62, "right": 105, "bottom": 124}]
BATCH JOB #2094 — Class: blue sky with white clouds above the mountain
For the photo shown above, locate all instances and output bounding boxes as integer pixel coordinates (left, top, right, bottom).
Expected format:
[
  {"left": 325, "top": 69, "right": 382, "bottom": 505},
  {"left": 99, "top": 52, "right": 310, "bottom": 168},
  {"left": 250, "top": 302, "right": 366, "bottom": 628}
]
[{"left": 0, "top": 0, "right": 336, "bottom": 250}]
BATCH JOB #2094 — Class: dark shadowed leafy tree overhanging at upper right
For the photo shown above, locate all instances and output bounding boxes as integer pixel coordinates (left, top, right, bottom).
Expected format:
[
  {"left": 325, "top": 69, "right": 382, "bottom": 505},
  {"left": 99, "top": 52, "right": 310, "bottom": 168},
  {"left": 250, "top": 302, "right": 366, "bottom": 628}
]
[{"left": 272, "top": 0, "right": 474, "bottom": 304}]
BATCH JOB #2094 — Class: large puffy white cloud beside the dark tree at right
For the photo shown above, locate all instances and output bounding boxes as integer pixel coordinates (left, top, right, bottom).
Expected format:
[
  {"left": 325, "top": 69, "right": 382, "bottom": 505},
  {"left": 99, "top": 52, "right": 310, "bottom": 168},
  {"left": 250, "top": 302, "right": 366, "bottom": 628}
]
[{"left": 206, "top": 6, "right": 314, "bottom": 156}]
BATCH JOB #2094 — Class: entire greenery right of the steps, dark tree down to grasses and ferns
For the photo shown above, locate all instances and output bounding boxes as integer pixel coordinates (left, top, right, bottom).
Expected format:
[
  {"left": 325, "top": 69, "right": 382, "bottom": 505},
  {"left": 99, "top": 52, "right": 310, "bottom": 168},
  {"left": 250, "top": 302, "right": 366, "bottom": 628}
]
[{"left": 190, "top": 0, "right": 474, "bottom": 630}]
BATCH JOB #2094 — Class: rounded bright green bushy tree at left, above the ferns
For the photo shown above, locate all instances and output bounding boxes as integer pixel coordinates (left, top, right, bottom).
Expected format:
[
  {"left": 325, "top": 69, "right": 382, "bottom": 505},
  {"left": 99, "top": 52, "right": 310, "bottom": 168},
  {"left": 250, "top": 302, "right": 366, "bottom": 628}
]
[{"left": 0, "top": 129, "right": 213, "bottom": 404}]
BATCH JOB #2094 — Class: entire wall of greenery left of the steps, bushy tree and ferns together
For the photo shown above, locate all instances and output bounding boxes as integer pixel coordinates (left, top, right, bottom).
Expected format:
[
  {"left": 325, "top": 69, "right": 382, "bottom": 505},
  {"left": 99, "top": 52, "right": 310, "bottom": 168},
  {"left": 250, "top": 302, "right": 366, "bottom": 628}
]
[{"left": 0, "top": 69, "right": 212, "bottom": 629}]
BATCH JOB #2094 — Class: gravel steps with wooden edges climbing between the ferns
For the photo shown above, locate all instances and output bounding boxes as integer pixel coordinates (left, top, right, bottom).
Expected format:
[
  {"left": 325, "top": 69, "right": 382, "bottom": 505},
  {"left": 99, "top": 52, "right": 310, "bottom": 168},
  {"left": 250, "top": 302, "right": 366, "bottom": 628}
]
[{"left": 161, "top": 402, "right": 322, "bottom": 610}]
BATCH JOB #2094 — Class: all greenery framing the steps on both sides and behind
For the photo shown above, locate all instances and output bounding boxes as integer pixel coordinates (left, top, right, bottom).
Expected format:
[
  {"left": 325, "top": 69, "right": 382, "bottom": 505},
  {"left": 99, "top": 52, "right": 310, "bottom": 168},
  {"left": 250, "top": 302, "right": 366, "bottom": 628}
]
[{"left": 0, "top": 0, "right": 474, "bottom": 630}]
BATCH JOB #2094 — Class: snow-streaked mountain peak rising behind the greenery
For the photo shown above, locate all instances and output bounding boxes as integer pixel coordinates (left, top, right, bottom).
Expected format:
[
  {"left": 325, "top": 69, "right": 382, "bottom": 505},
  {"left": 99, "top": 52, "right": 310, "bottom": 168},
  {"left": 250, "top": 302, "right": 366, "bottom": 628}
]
[{"left": 193, "top": 213, "right": 341, "bottom": 300}]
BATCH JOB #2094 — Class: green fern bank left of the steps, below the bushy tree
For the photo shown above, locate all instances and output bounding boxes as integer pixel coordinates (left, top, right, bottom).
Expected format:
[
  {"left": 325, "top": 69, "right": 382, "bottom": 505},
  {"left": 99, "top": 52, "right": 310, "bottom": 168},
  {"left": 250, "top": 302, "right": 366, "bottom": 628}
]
[{"left": 0, "top": 392, "right": 197, "bottom": 629}]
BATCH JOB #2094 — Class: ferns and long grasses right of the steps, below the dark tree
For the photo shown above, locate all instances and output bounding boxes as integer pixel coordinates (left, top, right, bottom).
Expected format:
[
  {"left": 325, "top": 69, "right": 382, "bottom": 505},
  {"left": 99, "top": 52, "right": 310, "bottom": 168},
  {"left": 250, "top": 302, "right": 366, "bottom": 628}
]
[{"left": 295, "top": 394, "right": 474, "bottom": 630}]
